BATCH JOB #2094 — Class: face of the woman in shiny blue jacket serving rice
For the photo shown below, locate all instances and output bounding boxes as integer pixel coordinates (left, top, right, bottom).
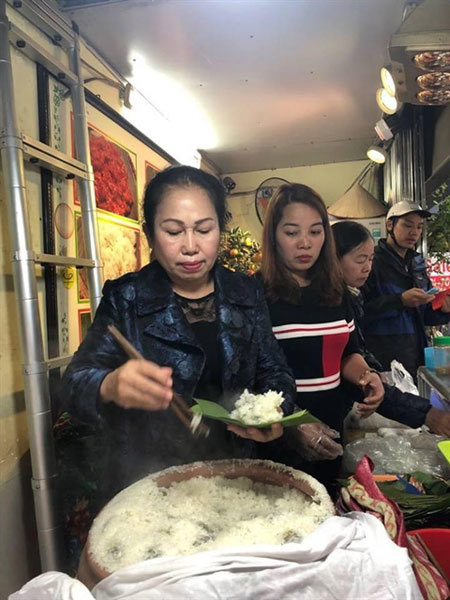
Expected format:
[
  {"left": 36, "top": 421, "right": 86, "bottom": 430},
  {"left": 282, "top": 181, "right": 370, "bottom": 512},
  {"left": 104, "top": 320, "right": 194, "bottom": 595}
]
[{"left": 151, "top": 186, "right": 220, "bottom": 284}]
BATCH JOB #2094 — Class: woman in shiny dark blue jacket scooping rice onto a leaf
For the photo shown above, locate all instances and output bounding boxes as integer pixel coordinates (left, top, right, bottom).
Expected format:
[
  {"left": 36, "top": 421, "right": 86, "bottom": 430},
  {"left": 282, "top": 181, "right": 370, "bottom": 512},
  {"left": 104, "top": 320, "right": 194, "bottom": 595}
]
[{"left": 61, "top": 166, "right": 295, "bottom": 497}]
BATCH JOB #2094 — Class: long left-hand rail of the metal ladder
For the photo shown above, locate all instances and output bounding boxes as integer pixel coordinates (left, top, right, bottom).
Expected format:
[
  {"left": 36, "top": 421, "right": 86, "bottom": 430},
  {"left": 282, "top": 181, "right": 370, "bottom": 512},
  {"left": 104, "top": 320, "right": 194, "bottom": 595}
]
[{"left": 0, "top": 0, "right": 63, "bottom": 571}]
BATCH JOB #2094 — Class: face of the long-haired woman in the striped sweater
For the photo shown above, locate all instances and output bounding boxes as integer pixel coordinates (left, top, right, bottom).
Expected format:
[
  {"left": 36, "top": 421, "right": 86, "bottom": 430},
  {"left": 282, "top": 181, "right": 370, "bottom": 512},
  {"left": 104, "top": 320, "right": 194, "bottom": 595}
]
[{"left": 275, "top": 202, "right": 325, "bottom": 283}]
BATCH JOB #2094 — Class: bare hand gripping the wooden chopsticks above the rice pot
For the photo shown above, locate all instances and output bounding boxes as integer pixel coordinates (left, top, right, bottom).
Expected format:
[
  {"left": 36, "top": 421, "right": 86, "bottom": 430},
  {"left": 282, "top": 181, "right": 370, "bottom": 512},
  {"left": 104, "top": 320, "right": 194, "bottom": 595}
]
[{"left": 100, "top": 359, "right": 172, "bottom": 410}]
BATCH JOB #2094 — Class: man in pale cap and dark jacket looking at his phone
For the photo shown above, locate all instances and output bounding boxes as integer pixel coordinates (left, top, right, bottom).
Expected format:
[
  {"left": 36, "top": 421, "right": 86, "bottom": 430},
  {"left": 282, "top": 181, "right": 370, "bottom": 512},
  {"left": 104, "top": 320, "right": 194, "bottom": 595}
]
[{"left": 362, "top": 200, "right": 450, "bottom": 379}]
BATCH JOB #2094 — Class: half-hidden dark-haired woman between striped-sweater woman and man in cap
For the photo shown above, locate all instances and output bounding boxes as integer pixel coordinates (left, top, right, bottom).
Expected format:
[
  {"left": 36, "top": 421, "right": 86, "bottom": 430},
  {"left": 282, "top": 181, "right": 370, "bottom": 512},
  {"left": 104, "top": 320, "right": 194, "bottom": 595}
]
[{"left": 332, "top": 221, "right": 450, "bottom": 436}]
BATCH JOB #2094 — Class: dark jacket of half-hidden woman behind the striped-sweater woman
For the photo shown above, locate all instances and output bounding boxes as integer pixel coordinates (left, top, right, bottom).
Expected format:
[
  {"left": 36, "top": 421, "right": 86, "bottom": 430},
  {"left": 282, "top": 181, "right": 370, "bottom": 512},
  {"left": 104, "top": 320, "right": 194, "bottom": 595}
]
[{"left": 347, "top": 288, "right": 431, "bottom": 427}]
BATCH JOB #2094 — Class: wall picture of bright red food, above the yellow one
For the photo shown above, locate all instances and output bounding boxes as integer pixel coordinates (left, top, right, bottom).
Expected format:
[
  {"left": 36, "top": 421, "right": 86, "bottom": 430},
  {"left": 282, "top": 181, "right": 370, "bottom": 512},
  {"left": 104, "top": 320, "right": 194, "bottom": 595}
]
[{"left": 89, "top": 130, "right": 136, "bottom": 218}]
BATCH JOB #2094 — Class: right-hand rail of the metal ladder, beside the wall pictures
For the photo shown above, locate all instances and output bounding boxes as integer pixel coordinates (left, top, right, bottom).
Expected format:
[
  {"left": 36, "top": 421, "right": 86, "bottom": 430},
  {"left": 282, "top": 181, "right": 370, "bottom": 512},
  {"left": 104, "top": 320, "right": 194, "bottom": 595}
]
[{"left": 71, "top": 32, "right": 103, "bottom": 317}]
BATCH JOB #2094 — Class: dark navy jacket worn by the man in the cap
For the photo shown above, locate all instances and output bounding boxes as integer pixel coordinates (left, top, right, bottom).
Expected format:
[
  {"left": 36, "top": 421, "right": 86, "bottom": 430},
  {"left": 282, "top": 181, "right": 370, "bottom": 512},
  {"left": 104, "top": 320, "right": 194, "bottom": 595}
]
[{"left": 362, "top": 240, "right": 450, "bottom": 377}]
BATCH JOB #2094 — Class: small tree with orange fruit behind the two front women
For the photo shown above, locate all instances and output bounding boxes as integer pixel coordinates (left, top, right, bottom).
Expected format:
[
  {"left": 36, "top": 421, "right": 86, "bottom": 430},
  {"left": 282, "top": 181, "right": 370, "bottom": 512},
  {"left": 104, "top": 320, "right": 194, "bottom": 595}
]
[{"left": 219, "top": 227, "right": 262, "bottom": 275}]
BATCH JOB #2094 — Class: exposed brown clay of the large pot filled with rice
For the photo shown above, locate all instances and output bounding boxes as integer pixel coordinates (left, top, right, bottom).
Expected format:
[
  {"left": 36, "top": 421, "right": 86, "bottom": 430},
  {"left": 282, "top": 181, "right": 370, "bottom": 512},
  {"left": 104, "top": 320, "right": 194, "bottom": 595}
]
[{"left": 77, "top": 459, "right": 331, "bottom": 589}]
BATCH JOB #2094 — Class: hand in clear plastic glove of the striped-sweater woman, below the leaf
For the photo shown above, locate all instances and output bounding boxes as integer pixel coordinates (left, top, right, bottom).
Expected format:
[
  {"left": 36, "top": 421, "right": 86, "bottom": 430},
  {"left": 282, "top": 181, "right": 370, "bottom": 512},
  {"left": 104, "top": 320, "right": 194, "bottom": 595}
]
[{"left": 295, "top": 423, "right": 344, "bottom": 460}]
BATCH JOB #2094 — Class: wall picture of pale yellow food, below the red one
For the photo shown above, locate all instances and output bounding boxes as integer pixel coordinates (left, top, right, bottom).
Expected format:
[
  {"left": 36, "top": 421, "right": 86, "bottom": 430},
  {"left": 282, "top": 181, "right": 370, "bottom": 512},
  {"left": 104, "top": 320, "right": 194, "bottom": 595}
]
[{"left": 75, "top": 212, "right": 141, "bottom": 302}]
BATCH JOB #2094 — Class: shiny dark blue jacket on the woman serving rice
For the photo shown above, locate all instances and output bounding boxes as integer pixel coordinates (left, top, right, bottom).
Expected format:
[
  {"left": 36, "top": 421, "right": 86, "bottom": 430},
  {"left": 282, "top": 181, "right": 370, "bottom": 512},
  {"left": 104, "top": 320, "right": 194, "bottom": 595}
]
[{"left": 60, "top": 262, "right": 295, "bottom": 491}]
